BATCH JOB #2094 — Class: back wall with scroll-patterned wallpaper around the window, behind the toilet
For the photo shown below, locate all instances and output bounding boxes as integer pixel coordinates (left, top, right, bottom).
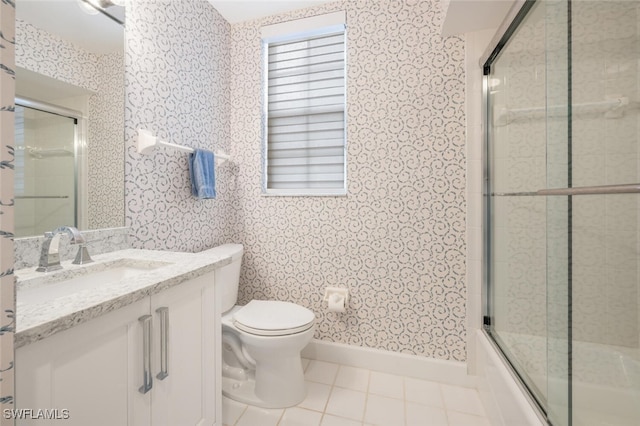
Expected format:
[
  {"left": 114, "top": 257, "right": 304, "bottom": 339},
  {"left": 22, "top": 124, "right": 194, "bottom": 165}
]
[{"left": 229, "top": 0, "right": 466, "bottom": 361}]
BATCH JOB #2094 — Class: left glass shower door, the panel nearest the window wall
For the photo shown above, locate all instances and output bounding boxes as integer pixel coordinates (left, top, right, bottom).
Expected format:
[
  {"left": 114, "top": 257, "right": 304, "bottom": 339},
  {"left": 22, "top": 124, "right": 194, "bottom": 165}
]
[{"left": 485, "top": 0, "right": 571, "bottom": 426}]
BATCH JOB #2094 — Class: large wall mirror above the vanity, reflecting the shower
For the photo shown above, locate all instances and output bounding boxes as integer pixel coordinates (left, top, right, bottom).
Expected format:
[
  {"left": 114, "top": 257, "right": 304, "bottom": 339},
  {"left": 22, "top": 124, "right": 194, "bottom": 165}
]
[{"left": 14, "top": 0, "right": 124, "bottom": 237}]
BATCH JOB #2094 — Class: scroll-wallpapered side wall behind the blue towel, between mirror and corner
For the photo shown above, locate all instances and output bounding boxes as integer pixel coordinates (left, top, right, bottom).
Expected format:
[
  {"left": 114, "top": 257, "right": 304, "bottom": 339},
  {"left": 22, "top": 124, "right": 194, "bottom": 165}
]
[{"left": 125, "top": 0, "right": 236, "bottom": 252}]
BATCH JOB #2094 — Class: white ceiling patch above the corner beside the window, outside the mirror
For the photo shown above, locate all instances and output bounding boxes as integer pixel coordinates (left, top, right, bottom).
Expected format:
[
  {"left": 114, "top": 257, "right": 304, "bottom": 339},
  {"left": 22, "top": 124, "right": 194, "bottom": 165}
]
[{"left": 209, "top": 0, "right": 335, "bottom": 24}]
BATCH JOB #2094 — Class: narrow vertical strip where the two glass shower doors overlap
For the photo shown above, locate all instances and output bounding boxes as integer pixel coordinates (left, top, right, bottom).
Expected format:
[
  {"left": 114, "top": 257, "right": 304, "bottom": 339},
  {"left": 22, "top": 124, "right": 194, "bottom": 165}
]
[{"left": 536, "top": 0, "right": 574, "bottom": 426}]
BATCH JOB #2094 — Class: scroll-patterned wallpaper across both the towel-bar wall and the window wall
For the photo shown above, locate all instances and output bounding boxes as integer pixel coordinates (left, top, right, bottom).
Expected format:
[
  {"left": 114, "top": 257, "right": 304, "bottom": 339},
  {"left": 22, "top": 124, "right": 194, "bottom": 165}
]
[{"left": 125, "top": 0, "right": 466, "bottom": 361}]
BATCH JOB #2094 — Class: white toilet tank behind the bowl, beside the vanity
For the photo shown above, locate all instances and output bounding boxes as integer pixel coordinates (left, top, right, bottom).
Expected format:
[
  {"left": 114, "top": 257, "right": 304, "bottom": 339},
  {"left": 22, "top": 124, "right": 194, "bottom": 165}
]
[{"left": 207, "top": 244, "right": 243, "bottom": 312}]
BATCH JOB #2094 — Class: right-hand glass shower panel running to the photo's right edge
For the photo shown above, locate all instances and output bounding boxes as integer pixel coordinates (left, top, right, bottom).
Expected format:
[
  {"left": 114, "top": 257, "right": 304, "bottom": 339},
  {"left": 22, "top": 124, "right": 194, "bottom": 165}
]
[{"left": 571, "top": 1, "right": 640, "bottom": 426}]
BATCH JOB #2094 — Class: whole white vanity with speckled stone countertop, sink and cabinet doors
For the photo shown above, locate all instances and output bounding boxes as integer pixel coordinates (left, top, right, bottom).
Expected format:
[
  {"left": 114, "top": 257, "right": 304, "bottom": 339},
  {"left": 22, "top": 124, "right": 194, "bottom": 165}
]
[{"left": 16, "top": 249, "right": 230, "bottom": 426}]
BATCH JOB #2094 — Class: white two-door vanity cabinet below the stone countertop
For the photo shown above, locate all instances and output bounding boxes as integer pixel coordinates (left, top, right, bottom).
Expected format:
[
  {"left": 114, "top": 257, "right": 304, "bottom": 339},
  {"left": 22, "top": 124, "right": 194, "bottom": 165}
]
[{"left": 16, "top": 273, "right": 222, "bottom": 426}]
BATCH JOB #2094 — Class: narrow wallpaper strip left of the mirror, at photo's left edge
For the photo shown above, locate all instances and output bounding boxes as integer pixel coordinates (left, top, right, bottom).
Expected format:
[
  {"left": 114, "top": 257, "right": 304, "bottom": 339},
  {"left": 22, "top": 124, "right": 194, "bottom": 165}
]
[{"left": 0, "top": 1, "right": 16, "bottom": 416}]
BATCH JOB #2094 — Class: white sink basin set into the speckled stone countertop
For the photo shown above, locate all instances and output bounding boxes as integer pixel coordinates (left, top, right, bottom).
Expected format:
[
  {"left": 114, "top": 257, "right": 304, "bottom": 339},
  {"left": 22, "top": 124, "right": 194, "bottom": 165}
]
[{"left": 17, "top": 259, "right": 171, "bottom": 305}]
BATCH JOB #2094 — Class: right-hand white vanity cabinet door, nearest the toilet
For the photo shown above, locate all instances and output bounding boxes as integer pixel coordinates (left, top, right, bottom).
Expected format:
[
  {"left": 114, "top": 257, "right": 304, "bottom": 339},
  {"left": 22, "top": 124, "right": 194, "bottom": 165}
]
[{"left": 151, "top": 273, "right": 220, "bottom": 426}]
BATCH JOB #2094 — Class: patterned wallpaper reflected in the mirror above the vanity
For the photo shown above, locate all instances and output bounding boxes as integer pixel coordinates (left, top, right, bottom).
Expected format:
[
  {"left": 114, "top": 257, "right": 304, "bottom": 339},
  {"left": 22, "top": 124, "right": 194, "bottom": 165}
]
[{"left": 16, "top": 20, "right": 124, "bottom": 233}]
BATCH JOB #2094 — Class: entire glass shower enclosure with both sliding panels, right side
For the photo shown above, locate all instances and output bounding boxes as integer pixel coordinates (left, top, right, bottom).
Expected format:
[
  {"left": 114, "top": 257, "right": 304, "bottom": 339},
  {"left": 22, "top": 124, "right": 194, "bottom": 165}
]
[{"left": 484, "top": 0, "right": 640, "bottom": 426}]
